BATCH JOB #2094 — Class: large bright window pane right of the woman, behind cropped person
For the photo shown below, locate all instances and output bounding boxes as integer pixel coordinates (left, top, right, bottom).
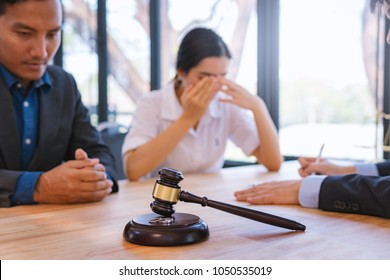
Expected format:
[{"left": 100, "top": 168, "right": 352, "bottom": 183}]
[{"left": 279, "top": 0, "right": 382, "bottom": 160}]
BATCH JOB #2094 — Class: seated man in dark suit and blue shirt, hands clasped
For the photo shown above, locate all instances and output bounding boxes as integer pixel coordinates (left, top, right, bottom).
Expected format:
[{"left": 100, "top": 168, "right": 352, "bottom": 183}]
[{"left": 0, "top": 0, "right": 118, "bottom": 207}]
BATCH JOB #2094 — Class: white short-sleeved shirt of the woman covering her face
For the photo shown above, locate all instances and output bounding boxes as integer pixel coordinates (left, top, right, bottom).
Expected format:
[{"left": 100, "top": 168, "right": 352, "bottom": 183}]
[{"left": 122, "top": 83, "right": 260, "bottom": 177}]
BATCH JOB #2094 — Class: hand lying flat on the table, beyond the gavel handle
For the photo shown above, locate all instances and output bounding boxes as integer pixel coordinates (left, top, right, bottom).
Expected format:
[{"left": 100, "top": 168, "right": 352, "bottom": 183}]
[{"left": 234, "top": 180, "right": 302, "bottom": 204}]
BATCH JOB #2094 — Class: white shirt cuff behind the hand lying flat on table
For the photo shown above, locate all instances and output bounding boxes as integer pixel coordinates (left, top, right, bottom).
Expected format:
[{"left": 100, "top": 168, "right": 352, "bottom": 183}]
[{"left": 298, "top": 175, "right": 326, "bottom": 208}]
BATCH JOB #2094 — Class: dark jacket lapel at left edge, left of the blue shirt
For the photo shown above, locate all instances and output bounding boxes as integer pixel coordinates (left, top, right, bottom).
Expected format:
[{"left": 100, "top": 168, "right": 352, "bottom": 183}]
[{"left": 0, "top": 78, "right": 20, "bottom": 170}]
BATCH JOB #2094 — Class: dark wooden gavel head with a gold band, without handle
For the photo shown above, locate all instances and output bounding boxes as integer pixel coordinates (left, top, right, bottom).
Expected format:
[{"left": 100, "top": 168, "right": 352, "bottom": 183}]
[{"left": 150, "top": 168, "right": 184, "bottom": 217}]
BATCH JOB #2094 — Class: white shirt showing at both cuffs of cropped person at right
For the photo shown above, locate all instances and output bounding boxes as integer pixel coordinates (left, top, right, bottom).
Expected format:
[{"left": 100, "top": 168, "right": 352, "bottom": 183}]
[{"left": 298, "top": 163, "right": 379, "bottom": 208}]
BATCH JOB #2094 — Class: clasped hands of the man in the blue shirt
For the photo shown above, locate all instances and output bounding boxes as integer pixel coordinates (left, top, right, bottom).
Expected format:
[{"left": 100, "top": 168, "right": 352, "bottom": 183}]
[{"left": 34, "top": 149, "right": 113, "bottom": 204}]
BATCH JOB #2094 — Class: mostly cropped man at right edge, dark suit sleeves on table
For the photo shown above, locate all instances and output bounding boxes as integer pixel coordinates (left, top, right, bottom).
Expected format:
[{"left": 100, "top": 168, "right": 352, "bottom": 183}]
[{"left": 235, "top": 0, "right": 390, "bottom": 218}]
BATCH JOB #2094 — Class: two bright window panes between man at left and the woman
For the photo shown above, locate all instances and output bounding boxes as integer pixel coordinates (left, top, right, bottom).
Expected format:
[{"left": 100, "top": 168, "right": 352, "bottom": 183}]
[{"left": 63, "top": 0, "right": 150, "bottom": 126}]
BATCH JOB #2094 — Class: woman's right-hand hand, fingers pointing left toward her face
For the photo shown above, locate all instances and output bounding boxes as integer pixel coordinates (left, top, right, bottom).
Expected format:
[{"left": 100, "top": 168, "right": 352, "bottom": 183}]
[{"left": 218, "top": 77, "right": 259, "bottom": 111}]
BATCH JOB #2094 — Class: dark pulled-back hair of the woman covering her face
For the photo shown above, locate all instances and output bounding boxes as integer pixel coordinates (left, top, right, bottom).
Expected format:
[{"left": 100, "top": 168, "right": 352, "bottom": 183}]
[{"left": 176, "top": 27, "right": 231, "bottom": 73}]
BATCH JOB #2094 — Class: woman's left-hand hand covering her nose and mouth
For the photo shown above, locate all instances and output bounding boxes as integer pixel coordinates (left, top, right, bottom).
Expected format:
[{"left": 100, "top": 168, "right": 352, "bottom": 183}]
[{"left": 180, "top": 77, "right": 219, "bottom": 121}]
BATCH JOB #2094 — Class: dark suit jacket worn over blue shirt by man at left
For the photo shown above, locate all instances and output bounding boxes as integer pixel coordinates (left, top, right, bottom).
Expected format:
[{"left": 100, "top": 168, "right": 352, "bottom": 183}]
[{"left": 0, "top": 66, "right": 118, "bottom": 207}]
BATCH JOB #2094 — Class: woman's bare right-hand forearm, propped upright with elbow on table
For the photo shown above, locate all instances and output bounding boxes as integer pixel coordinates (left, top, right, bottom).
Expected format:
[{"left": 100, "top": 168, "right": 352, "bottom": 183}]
[{"left": 252, "top": 99, "right": 283, "bottom": 171}]
